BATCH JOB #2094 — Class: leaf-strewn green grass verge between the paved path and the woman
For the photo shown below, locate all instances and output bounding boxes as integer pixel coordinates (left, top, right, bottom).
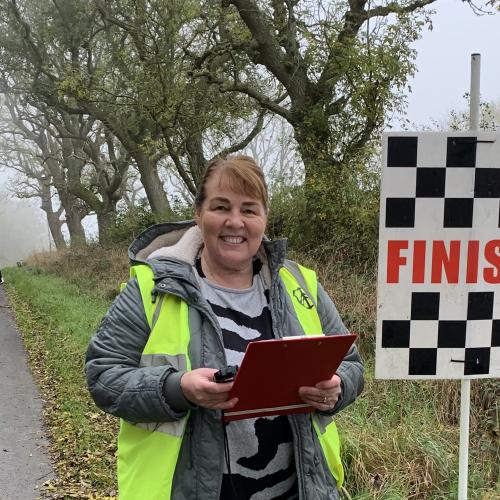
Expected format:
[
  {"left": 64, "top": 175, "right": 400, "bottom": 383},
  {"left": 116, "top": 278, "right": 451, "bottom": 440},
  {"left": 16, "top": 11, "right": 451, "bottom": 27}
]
[{"left": 5, "top": 268, "right": 118, "bottom": 499}]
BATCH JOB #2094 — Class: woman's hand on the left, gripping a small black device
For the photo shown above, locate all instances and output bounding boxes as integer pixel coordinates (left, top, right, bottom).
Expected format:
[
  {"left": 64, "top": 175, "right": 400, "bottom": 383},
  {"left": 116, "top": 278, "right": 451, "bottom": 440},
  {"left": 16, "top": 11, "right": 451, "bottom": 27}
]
[{"left": 181, "top": 368, "right": 238, "bottom": 410}]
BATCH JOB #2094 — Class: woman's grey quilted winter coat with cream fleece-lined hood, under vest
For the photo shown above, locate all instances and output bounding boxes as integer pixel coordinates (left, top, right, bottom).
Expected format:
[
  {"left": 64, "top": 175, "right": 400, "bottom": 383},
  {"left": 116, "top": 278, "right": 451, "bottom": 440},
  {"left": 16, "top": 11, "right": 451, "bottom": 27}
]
[{"left": 86, "top": 221, "right": 363, "bottom": 500}]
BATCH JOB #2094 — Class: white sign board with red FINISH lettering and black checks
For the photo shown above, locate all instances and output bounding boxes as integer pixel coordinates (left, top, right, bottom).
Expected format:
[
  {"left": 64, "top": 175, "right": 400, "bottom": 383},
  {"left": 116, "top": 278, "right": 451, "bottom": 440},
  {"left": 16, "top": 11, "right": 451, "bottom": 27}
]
[{"left": 376, "top": 132, "right": 500, "bottom": 379}]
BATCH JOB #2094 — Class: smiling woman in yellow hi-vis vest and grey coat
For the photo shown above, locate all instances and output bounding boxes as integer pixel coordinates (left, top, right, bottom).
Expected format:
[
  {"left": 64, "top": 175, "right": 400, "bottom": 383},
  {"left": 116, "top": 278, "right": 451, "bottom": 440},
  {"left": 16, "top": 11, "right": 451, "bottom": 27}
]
[{"left": 86, "top": 156, "right": 363, "bottom": 500}]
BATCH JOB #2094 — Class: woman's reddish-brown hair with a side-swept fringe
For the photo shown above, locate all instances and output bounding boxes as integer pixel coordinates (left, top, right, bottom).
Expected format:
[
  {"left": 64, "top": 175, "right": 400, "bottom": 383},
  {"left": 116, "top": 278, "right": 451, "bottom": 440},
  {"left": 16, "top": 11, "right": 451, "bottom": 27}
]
[{"left": 194, "top": 155, "right": 268, "bottom": 212}]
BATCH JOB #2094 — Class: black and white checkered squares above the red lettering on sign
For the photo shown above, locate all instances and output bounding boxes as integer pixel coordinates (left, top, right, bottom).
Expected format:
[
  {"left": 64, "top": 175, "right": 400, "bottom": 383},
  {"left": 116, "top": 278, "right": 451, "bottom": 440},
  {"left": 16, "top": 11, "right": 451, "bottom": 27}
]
[{"left": 385, "top": 136, "right": 500, "bottom": 232}]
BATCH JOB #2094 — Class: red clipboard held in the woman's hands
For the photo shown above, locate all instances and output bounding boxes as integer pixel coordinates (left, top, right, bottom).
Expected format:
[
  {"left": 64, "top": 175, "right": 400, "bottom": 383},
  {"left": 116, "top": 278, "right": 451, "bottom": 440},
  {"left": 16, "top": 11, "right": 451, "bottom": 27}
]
[{"left": 223, "top": 334, "right": 357, "bottom": 422}]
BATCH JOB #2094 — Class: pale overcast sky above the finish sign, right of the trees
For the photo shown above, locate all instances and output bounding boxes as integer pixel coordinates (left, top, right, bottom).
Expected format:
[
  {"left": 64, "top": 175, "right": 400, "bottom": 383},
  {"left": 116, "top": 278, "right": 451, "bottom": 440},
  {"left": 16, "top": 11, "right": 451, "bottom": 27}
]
[{"left": 407, "top": 0, "right": 500, "bottom": 125}]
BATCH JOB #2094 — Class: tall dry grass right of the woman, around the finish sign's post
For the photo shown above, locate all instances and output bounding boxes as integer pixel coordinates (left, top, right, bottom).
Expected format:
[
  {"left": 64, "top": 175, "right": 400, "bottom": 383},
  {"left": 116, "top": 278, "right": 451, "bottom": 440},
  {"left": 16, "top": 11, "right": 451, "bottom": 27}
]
[{"left": 296, "top": 251, "right": 500, "bottom": 500}]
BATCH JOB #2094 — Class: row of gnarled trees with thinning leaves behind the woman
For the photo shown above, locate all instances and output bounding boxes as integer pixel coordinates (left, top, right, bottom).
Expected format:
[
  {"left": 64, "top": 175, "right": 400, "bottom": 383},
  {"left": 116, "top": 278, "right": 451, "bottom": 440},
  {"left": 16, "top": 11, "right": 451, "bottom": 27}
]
[{"left": 0, "top": 0, "right": 442, "bottom": 250}]
